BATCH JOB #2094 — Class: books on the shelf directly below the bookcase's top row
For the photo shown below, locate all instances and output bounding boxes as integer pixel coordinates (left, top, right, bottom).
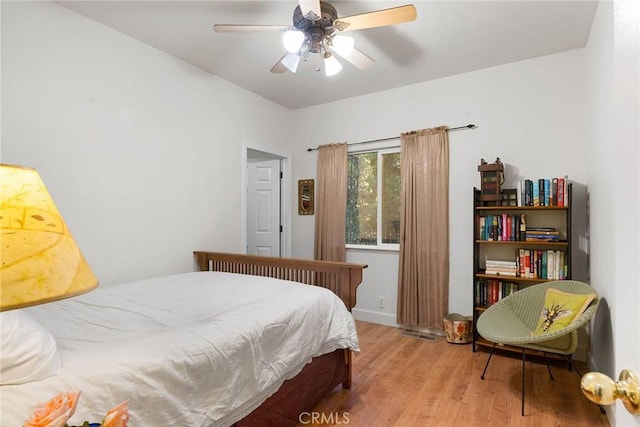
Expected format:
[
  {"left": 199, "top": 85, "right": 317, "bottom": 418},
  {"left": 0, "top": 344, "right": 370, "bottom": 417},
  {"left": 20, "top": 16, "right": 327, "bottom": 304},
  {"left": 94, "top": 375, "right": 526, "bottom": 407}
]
[{"left": 476, "top": 213, "right": 560, "bottom": 242}]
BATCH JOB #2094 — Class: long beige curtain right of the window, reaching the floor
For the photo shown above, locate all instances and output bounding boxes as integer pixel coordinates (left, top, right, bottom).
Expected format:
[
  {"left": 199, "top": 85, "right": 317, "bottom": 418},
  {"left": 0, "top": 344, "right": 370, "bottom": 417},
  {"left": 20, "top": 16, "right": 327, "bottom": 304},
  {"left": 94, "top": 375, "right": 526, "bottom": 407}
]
[{"left": 397, "top": 126, "right": 449, "bottom": 329}]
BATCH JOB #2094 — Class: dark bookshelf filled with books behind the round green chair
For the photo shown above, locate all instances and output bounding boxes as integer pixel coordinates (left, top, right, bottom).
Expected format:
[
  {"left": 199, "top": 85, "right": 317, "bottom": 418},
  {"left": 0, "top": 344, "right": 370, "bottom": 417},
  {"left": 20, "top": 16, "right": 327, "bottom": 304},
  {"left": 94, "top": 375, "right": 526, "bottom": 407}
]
[{"left": 472, "top": 184, "right": 572, "bottom": 352}]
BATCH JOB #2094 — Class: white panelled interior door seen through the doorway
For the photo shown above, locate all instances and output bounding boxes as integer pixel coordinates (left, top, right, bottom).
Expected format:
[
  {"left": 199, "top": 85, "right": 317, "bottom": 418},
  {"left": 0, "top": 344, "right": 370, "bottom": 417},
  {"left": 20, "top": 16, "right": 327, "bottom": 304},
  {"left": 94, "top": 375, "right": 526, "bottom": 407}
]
[{"left": 247, "top": 159, "right": 281, "bottom": 256}]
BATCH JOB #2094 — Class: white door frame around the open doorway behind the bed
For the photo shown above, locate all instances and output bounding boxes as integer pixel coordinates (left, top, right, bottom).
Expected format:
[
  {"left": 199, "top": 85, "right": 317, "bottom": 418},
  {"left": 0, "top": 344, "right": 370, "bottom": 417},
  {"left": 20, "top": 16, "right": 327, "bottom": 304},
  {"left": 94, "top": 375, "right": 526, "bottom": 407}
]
[{"left": 240, "top": 143, "right": 292, "bottom": 257}]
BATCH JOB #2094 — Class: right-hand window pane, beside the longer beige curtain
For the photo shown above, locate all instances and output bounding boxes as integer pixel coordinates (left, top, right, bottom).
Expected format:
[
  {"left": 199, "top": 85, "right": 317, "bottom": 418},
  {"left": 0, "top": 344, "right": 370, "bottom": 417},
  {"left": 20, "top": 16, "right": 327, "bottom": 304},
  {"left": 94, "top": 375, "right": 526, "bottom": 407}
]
[{"left": 382, "top": 153, "right": 400, "bottom": 243}]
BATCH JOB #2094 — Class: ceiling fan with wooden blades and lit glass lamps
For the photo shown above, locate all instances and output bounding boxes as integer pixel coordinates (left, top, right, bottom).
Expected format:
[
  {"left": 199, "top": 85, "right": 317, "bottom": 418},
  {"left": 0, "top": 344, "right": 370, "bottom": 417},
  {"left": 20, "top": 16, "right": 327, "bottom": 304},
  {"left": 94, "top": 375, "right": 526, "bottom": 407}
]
[{"left": 213, "top": 0, "right": 417, "bottom": 76}]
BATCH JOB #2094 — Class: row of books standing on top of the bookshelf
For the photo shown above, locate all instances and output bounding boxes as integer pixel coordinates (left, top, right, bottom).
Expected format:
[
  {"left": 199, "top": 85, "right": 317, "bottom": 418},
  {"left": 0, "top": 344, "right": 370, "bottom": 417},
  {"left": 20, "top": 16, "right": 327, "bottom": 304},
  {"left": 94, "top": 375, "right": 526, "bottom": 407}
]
[{"left": 516, "top": 175, "right": 569, "bottom": 206}]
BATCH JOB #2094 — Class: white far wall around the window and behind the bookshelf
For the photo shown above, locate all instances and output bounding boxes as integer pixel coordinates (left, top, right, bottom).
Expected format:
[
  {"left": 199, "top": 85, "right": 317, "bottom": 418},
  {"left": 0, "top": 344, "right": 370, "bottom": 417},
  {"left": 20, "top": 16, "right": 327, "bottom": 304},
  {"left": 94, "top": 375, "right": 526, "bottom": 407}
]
[{"left": 291, "top": 49, "right": 587, "bottom": 325}]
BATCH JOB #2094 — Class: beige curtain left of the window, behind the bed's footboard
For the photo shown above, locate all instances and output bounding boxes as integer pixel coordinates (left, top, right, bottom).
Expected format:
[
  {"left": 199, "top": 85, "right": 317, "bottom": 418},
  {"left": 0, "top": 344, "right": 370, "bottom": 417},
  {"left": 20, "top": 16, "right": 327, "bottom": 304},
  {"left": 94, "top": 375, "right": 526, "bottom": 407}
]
[{"left": 314, "top": 143, "right": 347, "bottom": 262}]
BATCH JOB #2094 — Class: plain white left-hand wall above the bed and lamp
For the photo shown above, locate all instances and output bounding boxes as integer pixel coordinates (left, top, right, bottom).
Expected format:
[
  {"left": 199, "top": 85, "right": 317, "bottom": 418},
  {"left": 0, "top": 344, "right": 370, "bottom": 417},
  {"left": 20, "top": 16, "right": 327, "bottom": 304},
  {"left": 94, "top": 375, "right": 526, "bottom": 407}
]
[{"left": 2, "top": 2, "right": 289, "bottom": 285}]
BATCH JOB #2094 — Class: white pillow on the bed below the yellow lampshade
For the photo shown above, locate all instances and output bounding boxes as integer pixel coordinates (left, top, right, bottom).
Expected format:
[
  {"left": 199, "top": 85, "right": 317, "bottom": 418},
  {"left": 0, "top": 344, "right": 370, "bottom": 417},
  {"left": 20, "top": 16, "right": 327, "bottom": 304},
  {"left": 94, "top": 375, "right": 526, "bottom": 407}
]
[{"left": 0, "top": 310, "right": 62, "bottom": 385}]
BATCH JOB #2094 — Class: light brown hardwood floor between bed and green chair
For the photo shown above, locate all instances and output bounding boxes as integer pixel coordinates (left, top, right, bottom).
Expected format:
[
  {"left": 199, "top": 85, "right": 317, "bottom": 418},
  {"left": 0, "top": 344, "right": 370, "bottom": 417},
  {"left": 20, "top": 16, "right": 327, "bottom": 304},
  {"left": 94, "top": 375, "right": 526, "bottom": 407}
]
[{"left": 299, "top": 321, "right": 609, "bottom": 427}]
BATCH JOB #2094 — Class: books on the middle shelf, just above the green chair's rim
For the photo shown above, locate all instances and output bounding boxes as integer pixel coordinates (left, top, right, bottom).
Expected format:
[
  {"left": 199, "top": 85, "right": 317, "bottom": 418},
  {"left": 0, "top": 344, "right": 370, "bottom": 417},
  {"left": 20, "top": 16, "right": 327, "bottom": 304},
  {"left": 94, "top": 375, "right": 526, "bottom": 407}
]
[{"left": 484, "top": 248, "right": 568, "bottom": 280}]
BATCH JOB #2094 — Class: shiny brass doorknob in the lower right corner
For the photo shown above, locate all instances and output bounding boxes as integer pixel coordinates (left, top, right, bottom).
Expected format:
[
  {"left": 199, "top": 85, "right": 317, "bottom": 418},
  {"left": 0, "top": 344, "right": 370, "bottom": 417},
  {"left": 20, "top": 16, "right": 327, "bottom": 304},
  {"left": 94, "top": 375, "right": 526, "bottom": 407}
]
[{"left": 580, "top": 369, "right": 640, "bottom": 415}]
